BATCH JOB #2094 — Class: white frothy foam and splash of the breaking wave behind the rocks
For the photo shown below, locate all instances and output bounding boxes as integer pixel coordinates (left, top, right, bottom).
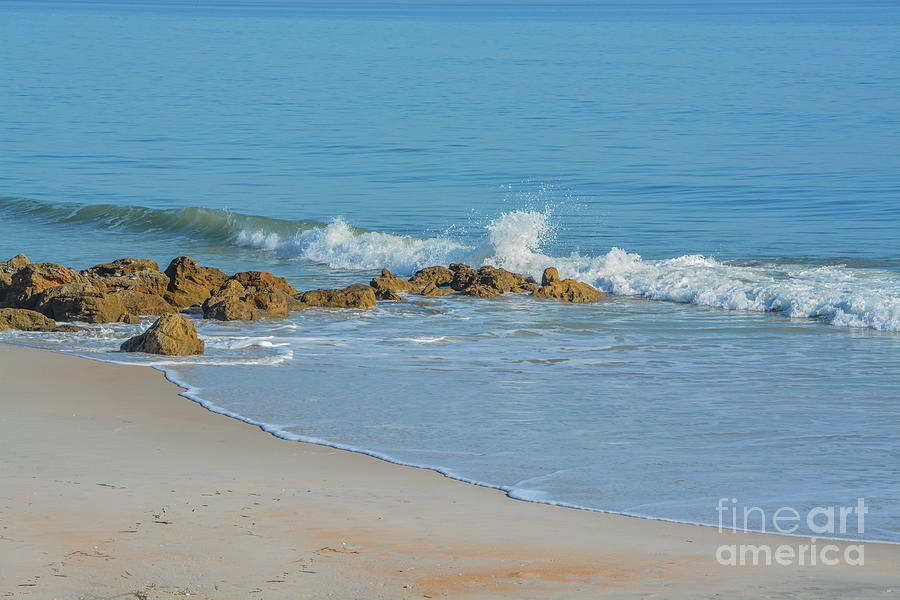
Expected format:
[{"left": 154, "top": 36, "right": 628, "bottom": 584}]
[{"left": 235, "top": 210, "right": 900, "bottom": 331}]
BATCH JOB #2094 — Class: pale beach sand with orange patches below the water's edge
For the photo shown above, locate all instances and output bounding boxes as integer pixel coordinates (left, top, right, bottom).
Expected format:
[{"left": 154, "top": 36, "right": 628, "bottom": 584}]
[{"left": 0, "top": 344, "right": 900, "bottom": 600}]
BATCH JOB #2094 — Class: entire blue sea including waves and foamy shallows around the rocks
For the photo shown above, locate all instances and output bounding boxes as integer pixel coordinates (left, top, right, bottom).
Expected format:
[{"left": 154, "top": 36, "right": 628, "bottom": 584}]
[{"left": 0, "top": 0, "right": 900, "bottom": 541}]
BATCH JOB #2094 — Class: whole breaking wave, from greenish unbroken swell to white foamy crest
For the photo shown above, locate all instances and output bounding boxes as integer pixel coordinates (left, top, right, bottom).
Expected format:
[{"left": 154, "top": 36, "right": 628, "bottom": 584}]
[{"left": 0, "top": 198, "right": 900, "bottom": 331}]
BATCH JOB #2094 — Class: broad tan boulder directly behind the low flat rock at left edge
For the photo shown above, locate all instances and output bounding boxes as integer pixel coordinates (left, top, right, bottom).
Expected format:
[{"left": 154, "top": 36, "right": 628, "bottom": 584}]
[{"left": 33, "top": 283, "right": 133, "bottom": 323}]
